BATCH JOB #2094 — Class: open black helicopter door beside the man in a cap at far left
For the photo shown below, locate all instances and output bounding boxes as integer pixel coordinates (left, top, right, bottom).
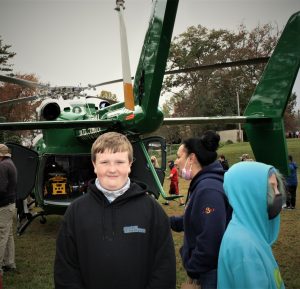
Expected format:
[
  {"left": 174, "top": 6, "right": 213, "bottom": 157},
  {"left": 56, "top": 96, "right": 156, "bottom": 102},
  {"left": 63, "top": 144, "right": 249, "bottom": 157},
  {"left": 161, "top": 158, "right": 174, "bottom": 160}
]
[{"left": 6, "top": 143, "right": 39, "bottom": 200}]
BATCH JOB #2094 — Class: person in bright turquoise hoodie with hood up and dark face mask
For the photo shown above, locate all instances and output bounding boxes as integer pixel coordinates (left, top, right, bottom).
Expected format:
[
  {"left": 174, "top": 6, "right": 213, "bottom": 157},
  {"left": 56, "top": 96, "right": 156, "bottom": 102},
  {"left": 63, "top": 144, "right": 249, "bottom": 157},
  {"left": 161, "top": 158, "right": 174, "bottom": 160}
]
[{"left": 218, "top": 162, "right": 285, "bottom": 289}]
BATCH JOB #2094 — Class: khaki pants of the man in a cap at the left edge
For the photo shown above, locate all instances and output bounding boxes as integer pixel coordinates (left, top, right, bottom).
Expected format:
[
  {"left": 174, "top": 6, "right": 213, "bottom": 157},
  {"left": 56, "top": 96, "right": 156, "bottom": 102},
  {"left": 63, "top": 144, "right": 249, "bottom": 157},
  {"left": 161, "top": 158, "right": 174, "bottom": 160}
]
[{"left": 0, "top": 204, "right": 16, "bottom": 269}]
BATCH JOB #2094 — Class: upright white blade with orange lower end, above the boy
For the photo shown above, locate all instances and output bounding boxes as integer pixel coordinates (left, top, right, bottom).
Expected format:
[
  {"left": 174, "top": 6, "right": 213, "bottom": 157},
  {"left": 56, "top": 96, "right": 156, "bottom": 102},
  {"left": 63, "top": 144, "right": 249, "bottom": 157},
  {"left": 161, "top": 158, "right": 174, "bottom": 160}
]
[{"left": 115, "top": 0, "right": 134, "bottom": 110}]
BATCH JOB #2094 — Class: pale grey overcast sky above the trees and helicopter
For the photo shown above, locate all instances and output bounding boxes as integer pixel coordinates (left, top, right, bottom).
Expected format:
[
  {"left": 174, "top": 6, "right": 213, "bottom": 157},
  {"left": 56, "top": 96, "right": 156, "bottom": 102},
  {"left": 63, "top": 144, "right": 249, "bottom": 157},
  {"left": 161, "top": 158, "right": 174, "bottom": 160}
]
[{"left": 0, "top": 0, "right": 300, "bottom": 105}]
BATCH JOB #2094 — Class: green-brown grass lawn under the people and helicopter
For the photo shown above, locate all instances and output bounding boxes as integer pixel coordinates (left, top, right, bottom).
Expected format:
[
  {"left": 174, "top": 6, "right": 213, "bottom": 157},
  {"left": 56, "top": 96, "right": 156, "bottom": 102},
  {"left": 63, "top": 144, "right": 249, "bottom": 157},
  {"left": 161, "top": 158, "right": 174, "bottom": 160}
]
[{"left": 3, "top": 139, "right": 300, "bottom": 289}]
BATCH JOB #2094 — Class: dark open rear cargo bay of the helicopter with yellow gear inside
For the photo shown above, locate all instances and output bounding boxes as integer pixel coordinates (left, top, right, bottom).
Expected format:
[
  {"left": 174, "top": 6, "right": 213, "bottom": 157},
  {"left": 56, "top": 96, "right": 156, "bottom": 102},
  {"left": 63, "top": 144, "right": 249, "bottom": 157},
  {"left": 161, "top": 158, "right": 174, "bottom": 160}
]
[{"left": 43, "top": 155, "right": 95, "bottom": 201}]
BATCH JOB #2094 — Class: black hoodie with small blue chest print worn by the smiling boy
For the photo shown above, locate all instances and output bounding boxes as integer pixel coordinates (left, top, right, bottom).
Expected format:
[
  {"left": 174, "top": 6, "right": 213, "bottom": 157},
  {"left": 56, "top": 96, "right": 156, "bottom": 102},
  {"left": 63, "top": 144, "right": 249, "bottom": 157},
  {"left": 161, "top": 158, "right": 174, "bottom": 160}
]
[{"left": 54, "top": 182, "right": 176, "bottom": 289}]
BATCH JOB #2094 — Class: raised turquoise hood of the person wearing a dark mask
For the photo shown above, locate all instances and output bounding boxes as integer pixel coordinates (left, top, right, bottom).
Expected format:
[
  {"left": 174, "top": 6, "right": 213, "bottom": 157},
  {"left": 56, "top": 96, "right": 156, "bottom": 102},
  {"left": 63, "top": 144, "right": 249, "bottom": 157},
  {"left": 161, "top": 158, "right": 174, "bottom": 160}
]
[{"left": 224, "top": 162, "right": 280, "bottom": 245}]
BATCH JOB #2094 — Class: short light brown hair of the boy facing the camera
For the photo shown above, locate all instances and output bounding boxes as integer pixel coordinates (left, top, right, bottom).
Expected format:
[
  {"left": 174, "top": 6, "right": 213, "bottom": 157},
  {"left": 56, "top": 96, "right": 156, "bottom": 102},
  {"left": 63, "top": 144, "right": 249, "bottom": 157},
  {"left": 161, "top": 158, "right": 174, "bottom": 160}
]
[{"left": 91, "top": 132, "right": 133, "bottom": 163}]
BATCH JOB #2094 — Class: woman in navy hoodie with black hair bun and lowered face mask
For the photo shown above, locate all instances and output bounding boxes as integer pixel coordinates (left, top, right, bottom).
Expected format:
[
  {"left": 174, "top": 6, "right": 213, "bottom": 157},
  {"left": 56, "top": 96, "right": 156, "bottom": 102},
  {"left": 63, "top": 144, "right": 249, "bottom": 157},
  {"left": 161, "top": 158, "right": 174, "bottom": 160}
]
[{"left": 170, "top": 131, "right": 232, "bottom": 289}]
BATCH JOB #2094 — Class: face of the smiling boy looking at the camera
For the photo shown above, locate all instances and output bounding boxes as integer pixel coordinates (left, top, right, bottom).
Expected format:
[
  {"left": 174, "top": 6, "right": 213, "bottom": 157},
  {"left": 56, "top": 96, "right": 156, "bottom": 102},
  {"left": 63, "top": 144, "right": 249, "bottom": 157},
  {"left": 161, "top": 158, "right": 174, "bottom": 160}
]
[{"left": 93, "top": 150, "right": 131, "bottom": 191}]
